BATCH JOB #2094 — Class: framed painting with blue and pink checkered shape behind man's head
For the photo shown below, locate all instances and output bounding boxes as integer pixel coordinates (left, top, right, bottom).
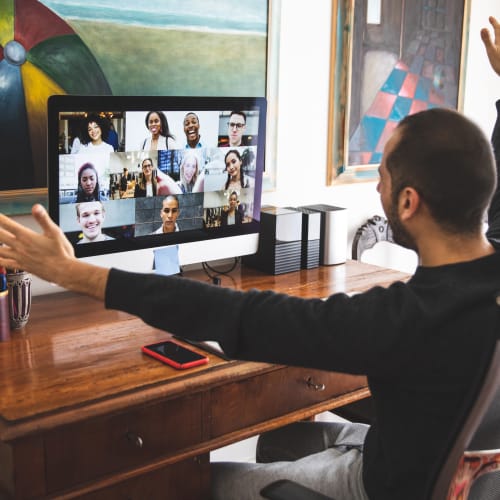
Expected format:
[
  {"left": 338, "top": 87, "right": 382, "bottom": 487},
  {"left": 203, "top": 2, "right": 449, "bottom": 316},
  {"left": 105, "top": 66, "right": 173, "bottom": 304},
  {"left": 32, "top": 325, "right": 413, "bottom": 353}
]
[{"left": 327, "top": 0, "right": 470, "bottom": 185}]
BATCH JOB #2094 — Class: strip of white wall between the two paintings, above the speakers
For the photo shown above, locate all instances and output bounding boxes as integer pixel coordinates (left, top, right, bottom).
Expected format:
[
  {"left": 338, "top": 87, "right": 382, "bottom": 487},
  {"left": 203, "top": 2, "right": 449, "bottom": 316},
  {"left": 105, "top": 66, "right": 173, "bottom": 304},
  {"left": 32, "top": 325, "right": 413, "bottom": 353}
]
[{"left": 263, "top": 0, "right": 382, "bottom": 242}]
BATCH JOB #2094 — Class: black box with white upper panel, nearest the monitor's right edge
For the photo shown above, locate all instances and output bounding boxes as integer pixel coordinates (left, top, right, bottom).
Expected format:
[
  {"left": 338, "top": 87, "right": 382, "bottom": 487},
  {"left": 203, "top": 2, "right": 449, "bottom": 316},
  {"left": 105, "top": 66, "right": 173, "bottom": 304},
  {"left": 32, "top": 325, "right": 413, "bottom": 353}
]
[{"left": 242, "top": 205, "right": 302, "bottom": 274}]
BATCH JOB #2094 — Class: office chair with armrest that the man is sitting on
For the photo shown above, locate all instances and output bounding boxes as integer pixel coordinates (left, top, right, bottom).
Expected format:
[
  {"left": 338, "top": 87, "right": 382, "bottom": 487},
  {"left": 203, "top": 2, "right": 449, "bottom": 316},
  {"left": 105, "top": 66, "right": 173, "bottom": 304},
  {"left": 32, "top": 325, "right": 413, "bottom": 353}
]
[{"left": 261, "top": 320, "right": 500, "bottom": 500}]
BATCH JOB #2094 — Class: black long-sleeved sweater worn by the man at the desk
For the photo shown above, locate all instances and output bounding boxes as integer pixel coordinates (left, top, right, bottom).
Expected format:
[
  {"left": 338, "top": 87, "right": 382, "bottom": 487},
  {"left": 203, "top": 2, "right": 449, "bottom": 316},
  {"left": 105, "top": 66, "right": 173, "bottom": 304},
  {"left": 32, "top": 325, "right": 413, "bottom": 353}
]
[{"left": 106, "top": 102, "right": 500, "bottom": 500}]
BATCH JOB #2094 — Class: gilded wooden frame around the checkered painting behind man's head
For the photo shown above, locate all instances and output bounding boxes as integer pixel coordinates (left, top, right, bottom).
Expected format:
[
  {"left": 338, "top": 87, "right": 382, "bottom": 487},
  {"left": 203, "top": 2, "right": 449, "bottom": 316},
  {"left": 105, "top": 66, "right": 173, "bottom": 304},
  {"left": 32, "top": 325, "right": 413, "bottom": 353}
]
[{"left": 326, "top": 0, "right": 471, "bottom": 185}]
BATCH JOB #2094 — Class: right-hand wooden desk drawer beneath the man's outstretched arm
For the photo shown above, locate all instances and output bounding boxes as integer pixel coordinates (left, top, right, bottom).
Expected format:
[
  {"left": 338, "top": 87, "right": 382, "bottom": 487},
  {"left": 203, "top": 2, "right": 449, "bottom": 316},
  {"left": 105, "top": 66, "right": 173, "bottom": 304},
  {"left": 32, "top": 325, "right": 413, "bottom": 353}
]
[{"left": 211, "top": 367, "right": 366, "bottom": 438}]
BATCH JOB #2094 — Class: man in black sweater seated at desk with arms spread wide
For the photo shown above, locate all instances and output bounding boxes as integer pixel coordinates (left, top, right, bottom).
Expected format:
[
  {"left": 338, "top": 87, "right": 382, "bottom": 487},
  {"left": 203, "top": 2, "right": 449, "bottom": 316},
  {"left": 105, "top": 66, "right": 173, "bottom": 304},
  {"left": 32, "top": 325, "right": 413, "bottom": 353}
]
[{"left": 0, "top": 17, "right": 500, "bottom": 500}]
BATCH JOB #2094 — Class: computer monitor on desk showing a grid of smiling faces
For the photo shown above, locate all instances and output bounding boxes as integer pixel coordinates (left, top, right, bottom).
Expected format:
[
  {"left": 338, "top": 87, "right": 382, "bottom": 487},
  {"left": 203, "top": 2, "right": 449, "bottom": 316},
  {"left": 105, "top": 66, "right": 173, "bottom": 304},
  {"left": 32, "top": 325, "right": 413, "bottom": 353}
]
[{"left": 48, "top": 95, "right": 266, "bottom": 268}]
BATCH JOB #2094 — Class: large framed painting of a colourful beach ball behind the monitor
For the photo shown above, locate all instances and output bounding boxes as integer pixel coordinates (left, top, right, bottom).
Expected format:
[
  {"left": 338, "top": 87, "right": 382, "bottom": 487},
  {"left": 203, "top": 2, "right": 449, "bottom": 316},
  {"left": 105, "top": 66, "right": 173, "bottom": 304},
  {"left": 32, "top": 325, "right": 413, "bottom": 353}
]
[{"left": 0, "top": 0, "right": 280, "bottom": 215}]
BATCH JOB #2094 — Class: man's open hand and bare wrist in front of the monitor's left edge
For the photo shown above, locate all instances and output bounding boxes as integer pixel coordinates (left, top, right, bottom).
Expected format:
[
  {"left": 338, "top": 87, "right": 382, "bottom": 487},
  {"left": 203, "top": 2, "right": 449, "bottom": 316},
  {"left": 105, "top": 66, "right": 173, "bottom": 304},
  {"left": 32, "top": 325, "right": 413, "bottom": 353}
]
[{"left": 0, "top": 205, "right": 109, "bottom": 299}]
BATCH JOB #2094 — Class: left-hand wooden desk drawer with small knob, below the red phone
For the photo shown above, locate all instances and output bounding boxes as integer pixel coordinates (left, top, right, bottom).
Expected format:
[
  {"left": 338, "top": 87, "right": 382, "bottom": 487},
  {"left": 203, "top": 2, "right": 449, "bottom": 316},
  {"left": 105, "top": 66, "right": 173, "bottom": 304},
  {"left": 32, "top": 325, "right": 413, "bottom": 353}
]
[{"left": 45, "top": 395, "right": 202, "bottom": 492}]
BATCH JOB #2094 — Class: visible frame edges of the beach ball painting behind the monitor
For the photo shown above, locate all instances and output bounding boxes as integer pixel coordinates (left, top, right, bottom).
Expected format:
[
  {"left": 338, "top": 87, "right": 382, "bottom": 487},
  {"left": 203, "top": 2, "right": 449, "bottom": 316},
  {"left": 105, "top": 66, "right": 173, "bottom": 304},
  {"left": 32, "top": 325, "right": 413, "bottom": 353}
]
[{"left": 0, "top": 0, "right": 281, "bottom": 216}]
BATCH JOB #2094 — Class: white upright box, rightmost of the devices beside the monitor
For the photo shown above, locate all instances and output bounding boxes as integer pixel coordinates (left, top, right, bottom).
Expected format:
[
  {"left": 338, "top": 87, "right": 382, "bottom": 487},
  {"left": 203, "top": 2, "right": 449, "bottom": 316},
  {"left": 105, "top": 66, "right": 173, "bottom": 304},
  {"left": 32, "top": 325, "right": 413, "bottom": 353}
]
[{"left": 299, "top": 204, "right": 347, "bottom": 266}]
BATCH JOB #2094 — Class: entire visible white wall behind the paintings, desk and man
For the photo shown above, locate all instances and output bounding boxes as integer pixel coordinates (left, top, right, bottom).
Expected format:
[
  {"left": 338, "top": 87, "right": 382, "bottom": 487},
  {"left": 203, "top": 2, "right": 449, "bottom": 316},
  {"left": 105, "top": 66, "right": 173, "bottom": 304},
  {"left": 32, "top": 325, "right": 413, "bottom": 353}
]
[{"left": 18, "top": 0, "right": 500, "bottom": 294}]
